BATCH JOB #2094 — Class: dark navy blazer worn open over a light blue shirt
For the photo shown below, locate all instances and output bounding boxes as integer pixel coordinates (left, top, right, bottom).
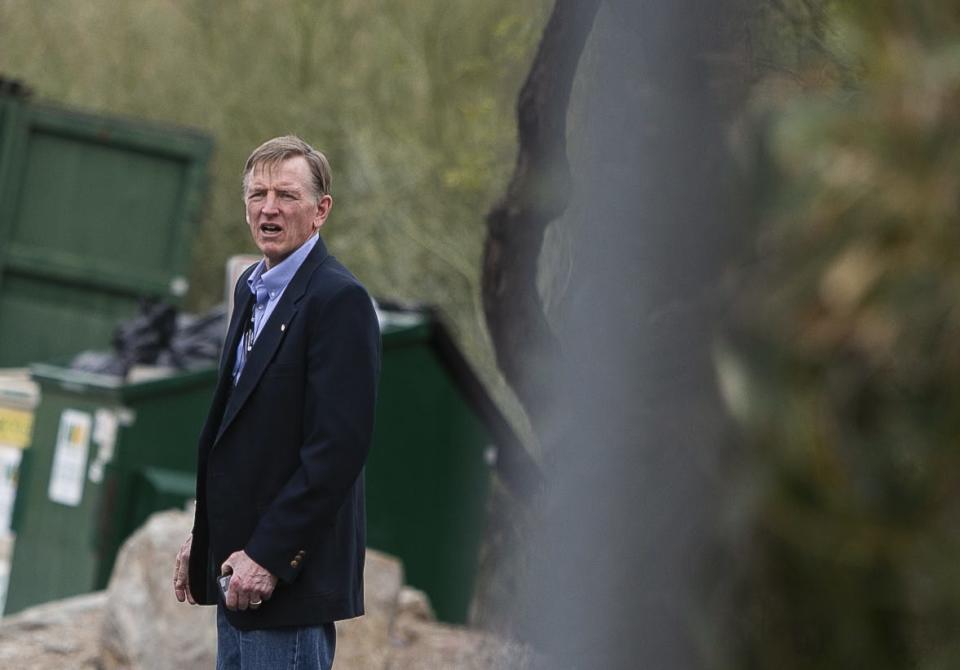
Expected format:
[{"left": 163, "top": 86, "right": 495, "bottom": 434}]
[{"left": 190, "top": 240, "right": 380, "bottom": 630}]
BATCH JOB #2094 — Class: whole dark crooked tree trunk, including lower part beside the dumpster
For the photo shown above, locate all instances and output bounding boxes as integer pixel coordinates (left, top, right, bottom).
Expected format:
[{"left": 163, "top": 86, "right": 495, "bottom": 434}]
[{"left": 470, "top": 0, "right": 600, "bottom": 636}]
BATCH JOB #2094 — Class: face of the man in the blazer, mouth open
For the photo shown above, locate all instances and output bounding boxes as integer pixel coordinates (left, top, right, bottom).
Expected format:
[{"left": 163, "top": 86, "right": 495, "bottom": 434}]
[{"left": 244, "top": 156, "right": 333, "bottom": 269}]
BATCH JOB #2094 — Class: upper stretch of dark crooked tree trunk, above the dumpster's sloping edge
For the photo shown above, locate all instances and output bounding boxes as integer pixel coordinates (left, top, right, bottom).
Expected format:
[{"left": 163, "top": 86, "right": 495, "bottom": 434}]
[{"left": 482, "top": 0, "right": 600, "bottom": 436}]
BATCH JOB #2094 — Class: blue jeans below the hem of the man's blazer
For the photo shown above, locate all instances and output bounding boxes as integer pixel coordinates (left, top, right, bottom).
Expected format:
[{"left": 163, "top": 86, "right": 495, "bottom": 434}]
[{"left": 217, "top": 603, "right": 337, "bottom": 670}]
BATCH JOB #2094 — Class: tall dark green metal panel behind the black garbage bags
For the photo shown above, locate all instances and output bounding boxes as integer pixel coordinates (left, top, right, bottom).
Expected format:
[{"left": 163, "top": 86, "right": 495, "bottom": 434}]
[{"left": 0, "top": 87, "right": 213, "bottom": 367}]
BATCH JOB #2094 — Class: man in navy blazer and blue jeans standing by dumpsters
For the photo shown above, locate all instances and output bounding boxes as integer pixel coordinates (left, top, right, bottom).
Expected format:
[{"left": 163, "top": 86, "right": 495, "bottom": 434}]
[{"left": 174, "top": 137, "right": 380, "bottom": 670}]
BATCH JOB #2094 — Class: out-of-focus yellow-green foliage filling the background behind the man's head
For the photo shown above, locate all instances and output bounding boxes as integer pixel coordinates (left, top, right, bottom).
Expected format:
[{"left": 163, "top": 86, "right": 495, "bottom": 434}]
[{"left": 0, "top": 0, "right": 550, "bottom": 438}]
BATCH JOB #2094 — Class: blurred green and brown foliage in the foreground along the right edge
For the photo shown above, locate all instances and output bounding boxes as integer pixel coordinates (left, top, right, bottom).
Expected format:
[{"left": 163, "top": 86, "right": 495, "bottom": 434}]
[{"left": 718, "top": 0, "right": 960, "bottom": 670}]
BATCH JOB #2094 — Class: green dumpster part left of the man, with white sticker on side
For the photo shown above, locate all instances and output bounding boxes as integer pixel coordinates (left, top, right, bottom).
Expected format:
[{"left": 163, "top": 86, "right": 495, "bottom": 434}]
[{"left": 5, "top": 365, "right": 216, "bottom": 614}]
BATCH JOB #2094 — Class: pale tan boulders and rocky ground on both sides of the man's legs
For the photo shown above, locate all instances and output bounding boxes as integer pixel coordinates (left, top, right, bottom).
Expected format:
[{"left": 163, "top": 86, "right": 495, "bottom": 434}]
[{"left": 0, "top": 511, "right": 543, "bottom": 670}]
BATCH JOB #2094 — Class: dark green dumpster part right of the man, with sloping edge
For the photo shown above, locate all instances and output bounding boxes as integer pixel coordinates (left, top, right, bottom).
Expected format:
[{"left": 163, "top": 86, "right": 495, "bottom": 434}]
[{"left": 366, "top": 310, "right": 526, "bottom": 623}]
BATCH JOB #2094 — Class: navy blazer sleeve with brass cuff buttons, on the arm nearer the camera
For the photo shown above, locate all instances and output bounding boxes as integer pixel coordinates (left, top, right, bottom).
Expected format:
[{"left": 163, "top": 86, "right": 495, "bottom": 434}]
[{"left": 245, "top": 284, "right": 381, "bottom": 582}]
